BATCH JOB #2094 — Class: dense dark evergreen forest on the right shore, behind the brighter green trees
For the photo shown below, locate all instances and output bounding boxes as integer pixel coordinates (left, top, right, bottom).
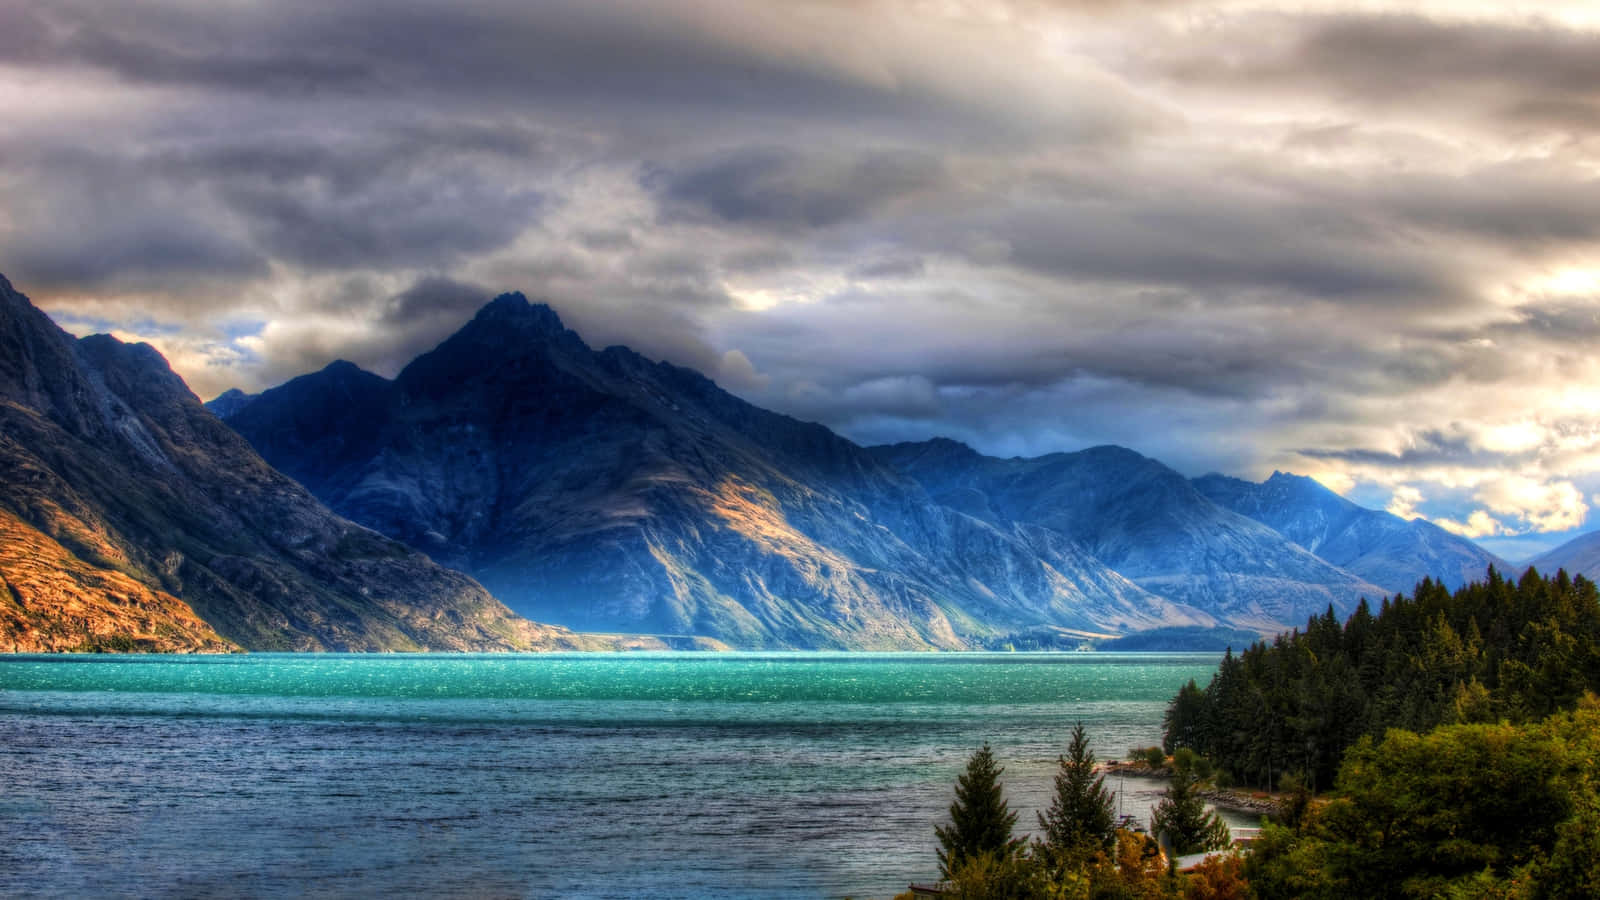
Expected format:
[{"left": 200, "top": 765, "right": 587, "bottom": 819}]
[{"left": 1165, "top": 569, "right": 1600, "bottom": 790}]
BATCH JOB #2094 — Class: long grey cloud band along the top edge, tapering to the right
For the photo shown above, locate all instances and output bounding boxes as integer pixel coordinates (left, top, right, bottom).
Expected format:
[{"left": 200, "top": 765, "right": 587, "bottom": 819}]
[{"left": 0, "top": 0, "right": 1081, "bottom": 140}]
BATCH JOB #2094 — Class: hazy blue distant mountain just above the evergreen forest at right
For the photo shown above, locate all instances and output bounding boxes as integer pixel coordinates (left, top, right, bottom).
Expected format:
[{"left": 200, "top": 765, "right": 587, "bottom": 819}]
[{"left": 1194, "top": 472, "right": 1517, "bottom": 594}]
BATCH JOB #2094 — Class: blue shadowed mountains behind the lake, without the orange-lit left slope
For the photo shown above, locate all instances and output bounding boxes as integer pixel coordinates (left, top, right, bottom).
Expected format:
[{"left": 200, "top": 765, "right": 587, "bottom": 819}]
[{"left": 211, "top": 295, "right": 1499, "bottom": 649}]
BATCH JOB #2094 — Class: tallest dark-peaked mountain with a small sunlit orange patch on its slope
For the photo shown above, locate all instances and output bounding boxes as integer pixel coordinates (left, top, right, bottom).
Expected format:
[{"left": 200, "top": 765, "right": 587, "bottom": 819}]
[{"left": 227, "top": 295, "right": 1213, "bottom": 649}]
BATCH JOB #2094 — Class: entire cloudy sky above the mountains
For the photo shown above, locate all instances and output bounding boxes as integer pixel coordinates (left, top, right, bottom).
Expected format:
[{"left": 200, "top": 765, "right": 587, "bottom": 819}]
[{"left": 0, "top": 0, "right": 1600, "bottom": 559}]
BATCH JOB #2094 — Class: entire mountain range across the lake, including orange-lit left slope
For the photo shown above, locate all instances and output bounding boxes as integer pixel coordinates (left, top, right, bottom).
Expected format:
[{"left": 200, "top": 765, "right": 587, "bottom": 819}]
[{"left": 0, "top": 265, "right": 1536, "bottom": 650}]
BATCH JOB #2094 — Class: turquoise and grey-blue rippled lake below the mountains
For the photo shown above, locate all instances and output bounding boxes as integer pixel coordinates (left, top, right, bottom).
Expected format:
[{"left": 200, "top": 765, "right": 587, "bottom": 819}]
[{"left": 0, "top": 653, "right": 1218, "bottom": 897}]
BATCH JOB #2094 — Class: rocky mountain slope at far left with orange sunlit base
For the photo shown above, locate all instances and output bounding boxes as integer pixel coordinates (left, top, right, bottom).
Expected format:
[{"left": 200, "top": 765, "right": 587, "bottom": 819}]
[{"left": 0, "top": 269, "right": 604, "bottom": 650}]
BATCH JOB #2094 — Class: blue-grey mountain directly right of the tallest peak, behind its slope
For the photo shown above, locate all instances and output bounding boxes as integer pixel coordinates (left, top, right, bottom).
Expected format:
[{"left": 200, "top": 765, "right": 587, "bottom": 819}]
[{"left": 874, "top": 440, "right": 1382, "bottom": 631}]
